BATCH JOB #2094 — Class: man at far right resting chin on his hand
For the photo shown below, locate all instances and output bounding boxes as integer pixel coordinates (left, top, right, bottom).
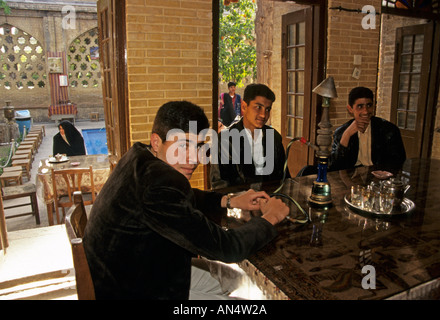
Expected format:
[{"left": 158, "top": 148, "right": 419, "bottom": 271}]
[{"left": 330, "top": 87, "right": 406, "bottom": 170}]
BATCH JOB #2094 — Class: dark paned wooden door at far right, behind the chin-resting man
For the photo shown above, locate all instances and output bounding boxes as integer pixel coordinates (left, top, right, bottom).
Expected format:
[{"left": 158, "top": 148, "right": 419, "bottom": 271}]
[{"left": 391, "top": 24, "right": 435, "bottom": 158}]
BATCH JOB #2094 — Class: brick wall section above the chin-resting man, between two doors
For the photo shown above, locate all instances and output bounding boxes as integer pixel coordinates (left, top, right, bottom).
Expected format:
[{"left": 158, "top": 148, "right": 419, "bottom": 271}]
[{"left": 327, "top": 0, "right": 381, "bottom": 129}]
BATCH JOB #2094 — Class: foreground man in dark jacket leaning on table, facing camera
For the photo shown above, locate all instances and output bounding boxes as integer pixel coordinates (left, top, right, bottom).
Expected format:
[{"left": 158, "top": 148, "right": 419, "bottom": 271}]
[{"left": 83, "top": 101, "right": 289, "bottom": 299}]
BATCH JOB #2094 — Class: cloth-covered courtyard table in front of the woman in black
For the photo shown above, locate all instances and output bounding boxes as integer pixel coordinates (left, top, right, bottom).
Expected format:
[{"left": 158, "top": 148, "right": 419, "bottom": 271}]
[{"left": 37, "top": 154, "right": 110, "bottom": 225}]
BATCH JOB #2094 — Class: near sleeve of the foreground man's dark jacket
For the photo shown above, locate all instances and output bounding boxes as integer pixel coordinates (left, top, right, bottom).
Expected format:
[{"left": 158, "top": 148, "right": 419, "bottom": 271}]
[{"left": 142, "top": 168, "right": 277, "bottom": 263}]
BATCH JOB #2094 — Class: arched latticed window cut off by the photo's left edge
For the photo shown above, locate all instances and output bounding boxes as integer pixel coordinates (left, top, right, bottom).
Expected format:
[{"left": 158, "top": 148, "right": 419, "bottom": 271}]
[{"left": 0, "top": 24, "right": 47, "bottom": 90}]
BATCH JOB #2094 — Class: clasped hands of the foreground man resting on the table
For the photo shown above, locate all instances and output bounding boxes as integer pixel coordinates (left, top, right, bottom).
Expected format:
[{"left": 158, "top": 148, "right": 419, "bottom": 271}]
[{"left": 223, "top": 189, "right": 289, "bottom": 225}]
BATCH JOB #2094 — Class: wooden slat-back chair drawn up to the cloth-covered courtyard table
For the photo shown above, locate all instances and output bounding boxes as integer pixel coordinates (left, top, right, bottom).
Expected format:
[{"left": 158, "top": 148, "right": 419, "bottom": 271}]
[{"left": 51, "top": 166, "right": 96, "bottom": 223}]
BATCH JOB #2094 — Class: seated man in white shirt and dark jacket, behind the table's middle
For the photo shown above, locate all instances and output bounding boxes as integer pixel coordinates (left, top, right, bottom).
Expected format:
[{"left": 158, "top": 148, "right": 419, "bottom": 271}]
[{"left": 210, "top": 84, "right": 290, "bottom": 189}]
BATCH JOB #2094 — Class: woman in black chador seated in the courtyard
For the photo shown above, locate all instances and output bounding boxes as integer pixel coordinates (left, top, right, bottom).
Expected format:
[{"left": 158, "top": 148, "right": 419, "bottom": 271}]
[{"left": 53, "top": 120, "right": 86, "bottom": 156}]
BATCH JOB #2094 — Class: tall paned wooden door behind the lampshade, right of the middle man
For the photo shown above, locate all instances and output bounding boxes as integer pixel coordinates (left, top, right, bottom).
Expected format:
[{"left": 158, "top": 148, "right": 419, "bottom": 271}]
[{"left": 281, "top": 7, "right": 316, "bottom": 176}]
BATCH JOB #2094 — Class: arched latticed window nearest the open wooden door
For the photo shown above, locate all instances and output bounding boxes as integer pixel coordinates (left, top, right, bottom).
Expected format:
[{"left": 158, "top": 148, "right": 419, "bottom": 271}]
[{"left": 67, "top": 28, "right": 101, "bottom": 88}]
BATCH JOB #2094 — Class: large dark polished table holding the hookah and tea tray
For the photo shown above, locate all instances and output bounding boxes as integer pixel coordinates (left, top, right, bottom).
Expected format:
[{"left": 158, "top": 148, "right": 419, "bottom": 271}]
[{"left": 222, "top": 159, "right": 440, "bottom": 300}]
